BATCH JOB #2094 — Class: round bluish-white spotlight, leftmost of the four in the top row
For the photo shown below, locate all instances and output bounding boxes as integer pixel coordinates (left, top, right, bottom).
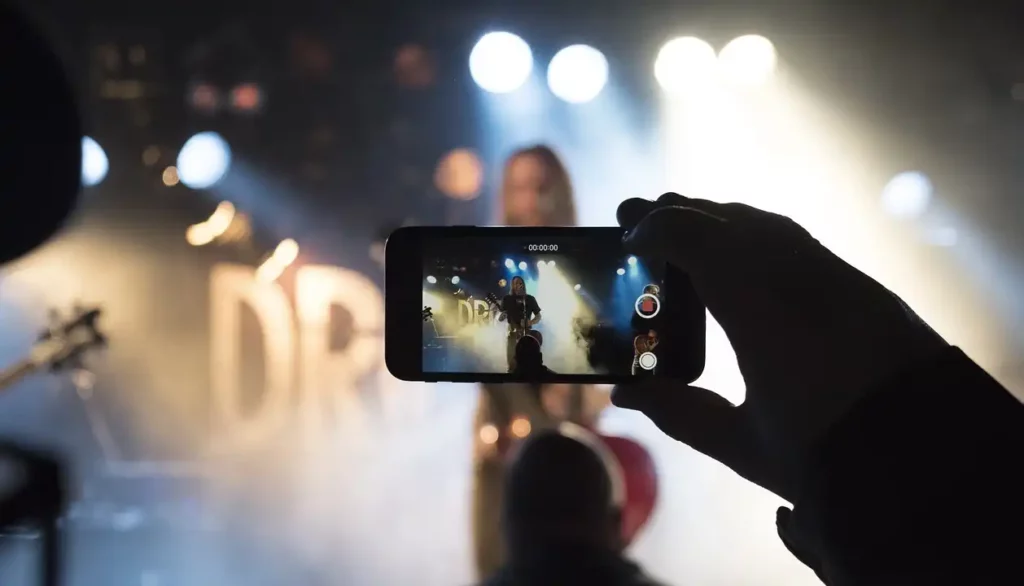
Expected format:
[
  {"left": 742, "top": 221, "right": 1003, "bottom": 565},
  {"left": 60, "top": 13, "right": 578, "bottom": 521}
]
[{"left": 469, "top": 33, "right": 534, "bottom": 93}]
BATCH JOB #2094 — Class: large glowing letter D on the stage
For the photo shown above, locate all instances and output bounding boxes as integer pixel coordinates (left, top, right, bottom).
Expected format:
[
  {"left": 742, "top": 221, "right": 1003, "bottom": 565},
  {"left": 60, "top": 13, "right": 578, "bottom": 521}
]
[{"left": 210, "top": 264, "right": 295, "bottom": 449}]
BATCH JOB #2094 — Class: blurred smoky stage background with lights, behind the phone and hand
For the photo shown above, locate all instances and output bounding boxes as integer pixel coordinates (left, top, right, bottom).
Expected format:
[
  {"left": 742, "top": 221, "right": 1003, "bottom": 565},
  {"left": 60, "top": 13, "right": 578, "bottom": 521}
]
[{"left": 0, "top": 0, "right": 1024, "bottom": 586}]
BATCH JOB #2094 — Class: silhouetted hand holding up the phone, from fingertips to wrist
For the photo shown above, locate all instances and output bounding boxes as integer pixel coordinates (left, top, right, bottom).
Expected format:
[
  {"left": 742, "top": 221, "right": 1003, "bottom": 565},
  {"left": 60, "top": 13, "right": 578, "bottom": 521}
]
[{"left": 612, "top": 194, "right": 947, "bottom": 502}]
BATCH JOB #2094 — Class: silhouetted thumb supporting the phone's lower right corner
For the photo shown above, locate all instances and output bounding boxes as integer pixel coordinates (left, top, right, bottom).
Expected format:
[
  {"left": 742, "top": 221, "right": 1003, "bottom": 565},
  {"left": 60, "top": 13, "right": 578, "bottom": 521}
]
[{"left": 611, "top": 379, "right": 751, "bottom": 467}]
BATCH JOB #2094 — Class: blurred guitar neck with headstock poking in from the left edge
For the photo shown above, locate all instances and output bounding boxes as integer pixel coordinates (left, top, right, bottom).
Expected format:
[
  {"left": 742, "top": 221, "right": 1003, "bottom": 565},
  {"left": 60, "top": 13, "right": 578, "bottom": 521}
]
[{"left": 0, "top": 308, "right": 106, "bottom": 390}]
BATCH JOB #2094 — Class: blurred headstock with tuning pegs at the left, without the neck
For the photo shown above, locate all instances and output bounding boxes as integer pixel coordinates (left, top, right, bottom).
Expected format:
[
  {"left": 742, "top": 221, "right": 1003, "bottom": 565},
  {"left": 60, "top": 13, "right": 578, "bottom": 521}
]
[{"left": 32, "top": 306, "right": 106, "bottom": 370}]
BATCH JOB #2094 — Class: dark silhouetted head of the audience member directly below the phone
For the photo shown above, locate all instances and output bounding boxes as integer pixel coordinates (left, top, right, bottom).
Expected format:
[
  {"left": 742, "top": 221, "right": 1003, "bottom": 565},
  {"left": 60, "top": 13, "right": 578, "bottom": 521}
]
[{"left": 503, "top": 423, "right": 625, "bottom": 557}]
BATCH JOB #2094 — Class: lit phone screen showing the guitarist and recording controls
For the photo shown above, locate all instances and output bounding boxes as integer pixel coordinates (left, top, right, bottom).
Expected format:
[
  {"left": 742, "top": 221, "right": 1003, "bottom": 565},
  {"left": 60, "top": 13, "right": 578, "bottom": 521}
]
[{"left": 421, "top": 228, "right": 684, "bottom": 379}]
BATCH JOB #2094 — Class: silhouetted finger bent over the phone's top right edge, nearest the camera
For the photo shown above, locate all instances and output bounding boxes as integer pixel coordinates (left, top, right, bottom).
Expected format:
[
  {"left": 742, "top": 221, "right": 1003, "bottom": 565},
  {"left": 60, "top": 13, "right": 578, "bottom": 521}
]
[{"left": 623, "top": 206, "right": 727, "bottom": 276}]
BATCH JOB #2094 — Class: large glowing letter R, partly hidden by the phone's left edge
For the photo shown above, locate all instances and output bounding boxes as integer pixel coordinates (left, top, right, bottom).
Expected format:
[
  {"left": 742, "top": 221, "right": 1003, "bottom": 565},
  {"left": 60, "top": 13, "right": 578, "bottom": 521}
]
[{"left": 295, "top": 266, "right": 384, "bottom": 433}]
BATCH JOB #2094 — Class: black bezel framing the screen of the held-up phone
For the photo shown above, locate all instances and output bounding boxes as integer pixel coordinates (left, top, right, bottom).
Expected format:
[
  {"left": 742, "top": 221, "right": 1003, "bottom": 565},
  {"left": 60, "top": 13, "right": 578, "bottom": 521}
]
[{"left": 384, "top": 226, "right": 707, "bottom": 384}]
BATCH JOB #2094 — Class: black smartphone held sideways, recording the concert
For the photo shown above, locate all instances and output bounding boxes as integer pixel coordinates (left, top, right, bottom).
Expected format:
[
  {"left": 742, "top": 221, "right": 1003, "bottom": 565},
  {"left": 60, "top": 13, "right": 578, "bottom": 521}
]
[{"left": 384, "top": 226, "right": 707, "bottom": 383}]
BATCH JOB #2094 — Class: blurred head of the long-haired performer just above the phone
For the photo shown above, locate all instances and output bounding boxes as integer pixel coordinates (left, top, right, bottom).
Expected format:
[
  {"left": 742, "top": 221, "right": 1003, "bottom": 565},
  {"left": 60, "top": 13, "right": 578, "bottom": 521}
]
[{"left": 501, "top": 144, "right": 577, "bottom": 225}]
